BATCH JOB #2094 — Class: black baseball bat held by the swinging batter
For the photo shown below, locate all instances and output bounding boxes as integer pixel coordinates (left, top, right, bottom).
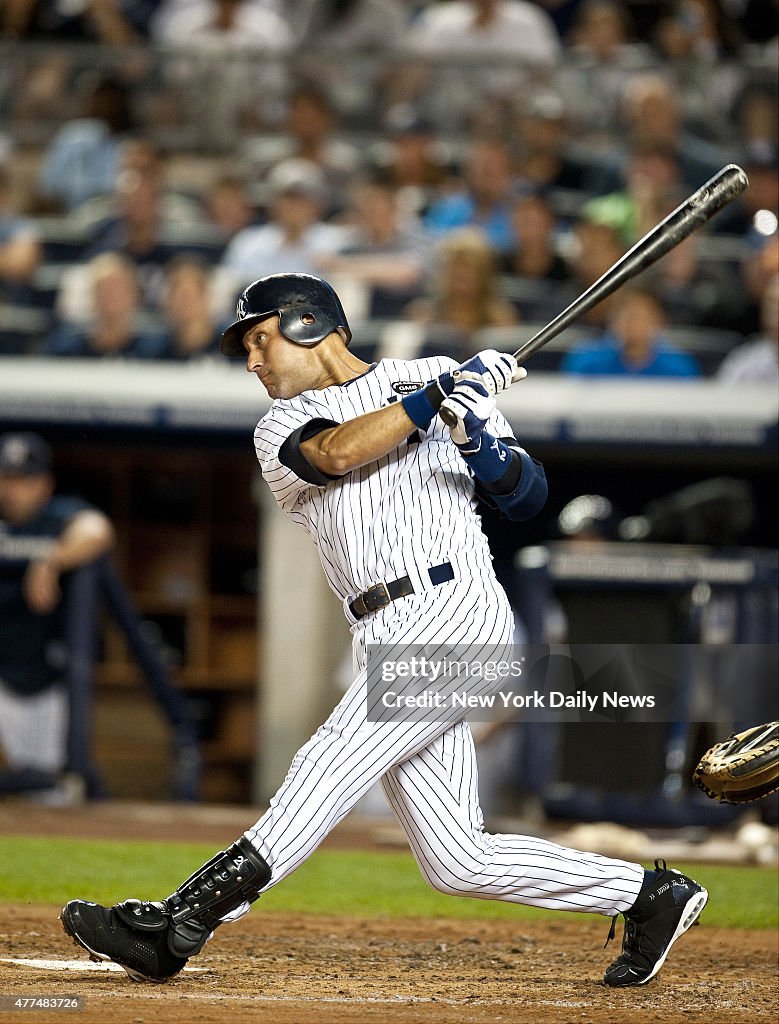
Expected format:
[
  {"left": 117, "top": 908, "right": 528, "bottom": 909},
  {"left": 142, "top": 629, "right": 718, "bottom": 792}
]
[{"left": 440, "top": 164, "right": 749, "bottom": 426}]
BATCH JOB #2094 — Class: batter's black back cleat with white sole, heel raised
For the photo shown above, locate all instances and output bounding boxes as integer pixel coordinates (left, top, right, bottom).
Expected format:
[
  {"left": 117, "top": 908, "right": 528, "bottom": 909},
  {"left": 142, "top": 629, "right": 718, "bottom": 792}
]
[{"left": 603, "top": 860, "right": 708, "bottom": 988}]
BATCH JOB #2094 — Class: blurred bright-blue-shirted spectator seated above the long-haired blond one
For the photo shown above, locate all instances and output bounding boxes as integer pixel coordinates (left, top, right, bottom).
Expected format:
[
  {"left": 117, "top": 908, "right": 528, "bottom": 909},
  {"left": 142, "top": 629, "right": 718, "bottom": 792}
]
[{"left": 425, "top": 138, "right": 516, "bottom": 253}]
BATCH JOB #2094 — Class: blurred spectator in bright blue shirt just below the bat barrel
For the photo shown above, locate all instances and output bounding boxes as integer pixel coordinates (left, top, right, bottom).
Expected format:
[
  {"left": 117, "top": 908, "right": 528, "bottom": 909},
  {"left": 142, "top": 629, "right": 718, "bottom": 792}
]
[{"left": 560, "top": 287, "right": 700, "bottom": 378}]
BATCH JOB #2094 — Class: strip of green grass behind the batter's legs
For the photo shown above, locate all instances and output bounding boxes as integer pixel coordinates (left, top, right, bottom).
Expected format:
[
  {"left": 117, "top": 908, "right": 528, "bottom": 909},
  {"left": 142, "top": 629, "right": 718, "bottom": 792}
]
[{"left": 0, "top": 836, "right": 779, "bottom": 929}]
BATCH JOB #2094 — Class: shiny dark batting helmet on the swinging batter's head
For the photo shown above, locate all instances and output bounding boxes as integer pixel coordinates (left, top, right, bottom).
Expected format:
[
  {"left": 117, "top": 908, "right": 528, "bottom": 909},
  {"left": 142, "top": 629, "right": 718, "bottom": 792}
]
[{"left": 220, "top": 273, "right": 351, "bottom": 355}]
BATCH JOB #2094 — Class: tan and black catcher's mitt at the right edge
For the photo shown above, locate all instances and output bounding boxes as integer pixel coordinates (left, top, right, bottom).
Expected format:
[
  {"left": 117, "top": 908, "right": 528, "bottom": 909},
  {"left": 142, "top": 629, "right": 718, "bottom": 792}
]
[{"left": 692, "top": 722, "right": 779, "bottom": 804}]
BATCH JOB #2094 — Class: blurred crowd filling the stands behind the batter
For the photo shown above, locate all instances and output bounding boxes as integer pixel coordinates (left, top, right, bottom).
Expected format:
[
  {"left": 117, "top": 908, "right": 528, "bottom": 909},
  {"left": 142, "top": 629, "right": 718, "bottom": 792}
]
[{"left": 0, "top": 0, "right": 779, "bottom": 384}]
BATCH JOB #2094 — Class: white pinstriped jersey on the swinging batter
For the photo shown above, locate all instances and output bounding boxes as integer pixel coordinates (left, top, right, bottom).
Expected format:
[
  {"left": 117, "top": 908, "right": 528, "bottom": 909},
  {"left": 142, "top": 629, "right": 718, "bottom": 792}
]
[{"left": 255, "top": 356, "right": 520, "bottom": 600}]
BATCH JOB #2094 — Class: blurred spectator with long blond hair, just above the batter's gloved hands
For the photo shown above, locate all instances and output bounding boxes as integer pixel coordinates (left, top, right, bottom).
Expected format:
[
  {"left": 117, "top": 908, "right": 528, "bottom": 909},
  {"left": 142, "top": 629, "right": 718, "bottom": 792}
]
[{"left": 406, "top": 227, "right": 519, "bottom": 350}]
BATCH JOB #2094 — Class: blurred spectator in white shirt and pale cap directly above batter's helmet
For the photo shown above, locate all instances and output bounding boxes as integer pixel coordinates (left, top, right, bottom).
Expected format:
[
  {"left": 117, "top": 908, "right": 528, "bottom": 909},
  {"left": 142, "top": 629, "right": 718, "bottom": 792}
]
[{"left": 221, "top": 158, "right": 346, "bottom": 292}]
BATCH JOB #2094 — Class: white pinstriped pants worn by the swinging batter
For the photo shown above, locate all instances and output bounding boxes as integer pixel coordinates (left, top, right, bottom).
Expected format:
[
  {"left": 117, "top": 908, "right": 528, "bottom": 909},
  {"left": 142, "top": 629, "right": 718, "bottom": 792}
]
[{"left": 246, "top": 571, "right": 644, "bottom": 915}]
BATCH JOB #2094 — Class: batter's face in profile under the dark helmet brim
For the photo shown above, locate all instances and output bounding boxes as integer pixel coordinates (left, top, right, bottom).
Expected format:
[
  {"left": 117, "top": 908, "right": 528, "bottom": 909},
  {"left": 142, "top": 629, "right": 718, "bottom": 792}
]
[{"left": 244, "top": 315, "right": 321, "bottom": 398}]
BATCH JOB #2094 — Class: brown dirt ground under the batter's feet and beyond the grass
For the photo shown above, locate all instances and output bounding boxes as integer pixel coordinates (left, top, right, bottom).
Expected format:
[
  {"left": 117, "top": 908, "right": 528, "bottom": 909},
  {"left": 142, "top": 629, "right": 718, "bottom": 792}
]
[{"left": 0, "top": 807, "right": 779, "bottom": 1024}]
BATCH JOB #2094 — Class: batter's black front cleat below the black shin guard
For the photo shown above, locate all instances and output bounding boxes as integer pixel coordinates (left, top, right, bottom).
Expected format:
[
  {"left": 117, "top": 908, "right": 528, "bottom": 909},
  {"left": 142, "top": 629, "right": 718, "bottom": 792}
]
[{"left": 59, "top": 899, "right": 187, "bottom": 983}]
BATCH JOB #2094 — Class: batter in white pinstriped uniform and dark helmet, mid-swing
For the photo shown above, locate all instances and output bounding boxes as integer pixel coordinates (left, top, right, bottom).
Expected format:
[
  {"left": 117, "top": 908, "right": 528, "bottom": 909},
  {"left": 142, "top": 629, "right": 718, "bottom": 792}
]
[{"left": 60, "top": 274, "right": 707, "bottom": 986}]
